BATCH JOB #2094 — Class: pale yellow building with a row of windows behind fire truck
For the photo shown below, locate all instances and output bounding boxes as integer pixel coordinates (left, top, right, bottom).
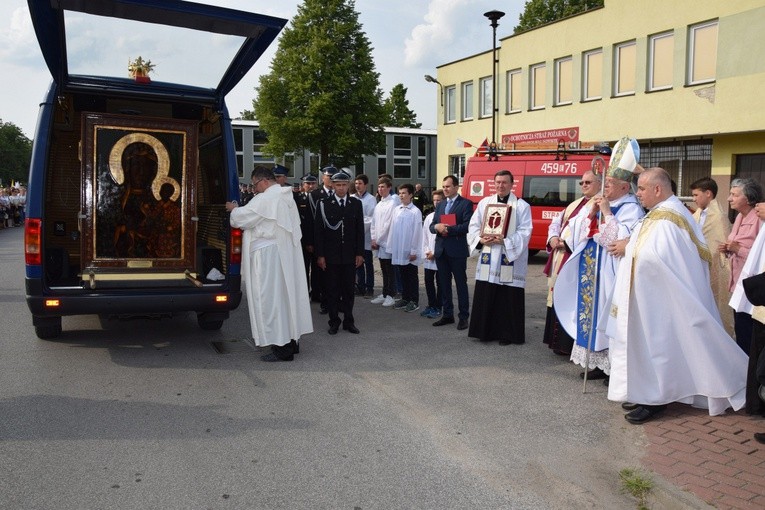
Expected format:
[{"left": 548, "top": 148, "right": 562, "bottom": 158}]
[{"left": 436, "top": 0, "right": 765, "bottom": 202}]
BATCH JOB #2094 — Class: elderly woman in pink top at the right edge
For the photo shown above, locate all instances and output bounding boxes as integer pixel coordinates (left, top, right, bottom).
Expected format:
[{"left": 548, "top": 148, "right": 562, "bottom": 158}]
[{"left": 718, "top": 179, "right": 763, "bottom": 354}]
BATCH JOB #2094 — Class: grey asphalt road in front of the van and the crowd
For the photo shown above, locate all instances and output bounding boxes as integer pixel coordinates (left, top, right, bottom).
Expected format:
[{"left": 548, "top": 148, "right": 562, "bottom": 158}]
[{"left": 0, "top": 229, "right": 705, "bottom": 510}]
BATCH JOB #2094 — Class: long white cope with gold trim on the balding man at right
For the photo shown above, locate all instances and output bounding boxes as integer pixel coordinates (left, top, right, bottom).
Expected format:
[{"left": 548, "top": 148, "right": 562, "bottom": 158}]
[{"left": 606, "top": 196, "right": 747, "bottom": 416}]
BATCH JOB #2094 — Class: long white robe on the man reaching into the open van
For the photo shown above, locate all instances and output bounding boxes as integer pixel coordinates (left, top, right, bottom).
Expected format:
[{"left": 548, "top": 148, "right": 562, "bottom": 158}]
[{"left": 231, "top": 185, "right": 313, "bottom": 347}]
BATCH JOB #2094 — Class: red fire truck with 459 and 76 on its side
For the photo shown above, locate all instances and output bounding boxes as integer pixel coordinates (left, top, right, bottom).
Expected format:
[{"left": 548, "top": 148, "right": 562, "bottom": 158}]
[{"left": 461, "top": 135, "right": 611, "bottom": 255}]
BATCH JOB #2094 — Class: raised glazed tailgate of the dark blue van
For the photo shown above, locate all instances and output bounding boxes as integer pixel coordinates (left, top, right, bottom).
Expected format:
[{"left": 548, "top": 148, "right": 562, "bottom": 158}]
[{"left": 28, "top": 0, "right": 287, "bottom": 102}]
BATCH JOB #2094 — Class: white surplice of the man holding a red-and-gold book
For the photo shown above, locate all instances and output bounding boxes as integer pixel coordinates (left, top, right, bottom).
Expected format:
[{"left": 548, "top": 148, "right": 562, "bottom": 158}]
[{"left": 467, "top": 193, "right": 531, "bottom": 289}]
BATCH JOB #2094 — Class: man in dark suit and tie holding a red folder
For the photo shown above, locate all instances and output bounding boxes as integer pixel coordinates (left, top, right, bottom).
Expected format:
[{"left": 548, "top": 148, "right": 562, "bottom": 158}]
[{"left": 430, "top": 175, "right": 473, "bottom": 330}]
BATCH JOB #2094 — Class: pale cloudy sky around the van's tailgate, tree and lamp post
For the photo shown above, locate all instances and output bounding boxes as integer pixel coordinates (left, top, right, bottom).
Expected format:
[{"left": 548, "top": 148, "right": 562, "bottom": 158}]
[{"left": 0, "top": 0, "right": 525, "bottom": 138}]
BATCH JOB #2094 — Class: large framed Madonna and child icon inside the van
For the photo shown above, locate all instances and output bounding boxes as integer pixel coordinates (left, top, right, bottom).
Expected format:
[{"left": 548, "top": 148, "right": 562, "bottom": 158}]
[{"left": 81, "top": 113, "right": 198, "bottom": 272}]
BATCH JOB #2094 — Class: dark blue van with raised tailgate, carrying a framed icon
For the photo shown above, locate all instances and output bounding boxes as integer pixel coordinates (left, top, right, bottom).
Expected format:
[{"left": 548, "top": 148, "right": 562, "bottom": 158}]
[{"left": 24, "top": 0, "right": 286, "bottom": 338}]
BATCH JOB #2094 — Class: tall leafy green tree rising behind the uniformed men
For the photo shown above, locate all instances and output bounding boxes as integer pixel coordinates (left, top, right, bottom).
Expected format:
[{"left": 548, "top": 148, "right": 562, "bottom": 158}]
[{"left": 252, "top": 0, "right": 385, "bottom": 165}]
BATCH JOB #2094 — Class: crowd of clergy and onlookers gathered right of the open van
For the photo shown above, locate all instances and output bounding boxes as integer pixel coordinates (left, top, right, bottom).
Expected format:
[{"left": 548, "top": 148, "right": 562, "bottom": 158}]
[{"left": 227, "top": 147, "right": 765, "bottom": 438}]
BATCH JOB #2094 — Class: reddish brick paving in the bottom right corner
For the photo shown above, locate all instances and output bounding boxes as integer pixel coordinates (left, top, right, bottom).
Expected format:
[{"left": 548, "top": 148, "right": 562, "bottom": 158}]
[{"left": 643, "top": 404, "right": 765, "bottom": 510}]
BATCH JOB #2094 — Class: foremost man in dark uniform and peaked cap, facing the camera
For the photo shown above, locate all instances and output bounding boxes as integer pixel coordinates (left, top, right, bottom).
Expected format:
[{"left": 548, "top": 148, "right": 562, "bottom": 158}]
[{"left": 314, "top": 172, "right": 364, "bottom": 335}]
